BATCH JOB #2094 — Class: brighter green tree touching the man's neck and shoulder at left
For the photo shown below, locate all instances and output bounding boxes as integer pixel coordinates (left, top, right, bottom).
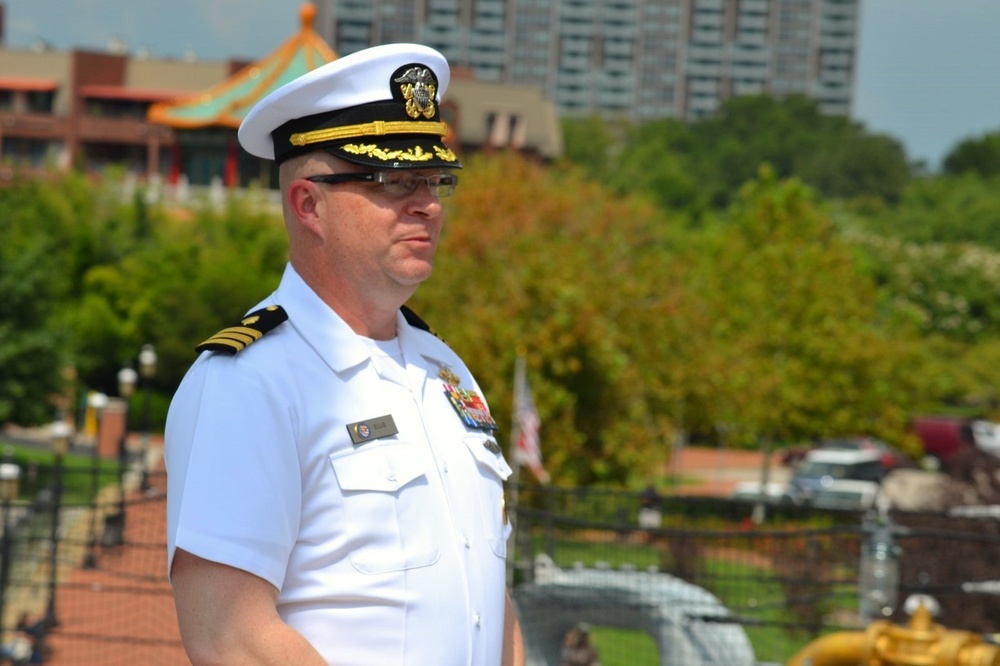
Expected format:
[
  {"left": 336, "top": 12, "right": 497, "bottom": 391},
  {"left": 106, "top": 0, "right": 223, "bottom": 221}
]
[{"left": 67, "top": 187, "right": 287, "bottom": 391}]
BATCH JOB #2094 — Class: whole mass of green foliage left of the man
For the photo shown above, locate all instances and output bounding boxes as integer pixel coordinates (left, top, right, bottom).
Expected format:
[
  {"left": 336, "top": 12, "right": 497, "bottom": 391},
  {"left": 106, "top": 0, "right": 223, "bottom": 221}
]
[{"left": 0, "top": 174, "right": 287, "bottom": 424}]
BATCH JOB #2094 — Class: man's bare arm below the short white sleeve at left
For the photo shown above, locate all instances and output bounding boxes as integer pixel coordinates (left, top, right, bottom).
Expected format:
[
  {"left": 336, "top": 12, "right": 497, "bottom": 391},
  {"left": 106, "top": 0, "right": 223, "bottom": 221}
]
[{"left": 171, "top": 548, "right": 326, "bottom": 666}]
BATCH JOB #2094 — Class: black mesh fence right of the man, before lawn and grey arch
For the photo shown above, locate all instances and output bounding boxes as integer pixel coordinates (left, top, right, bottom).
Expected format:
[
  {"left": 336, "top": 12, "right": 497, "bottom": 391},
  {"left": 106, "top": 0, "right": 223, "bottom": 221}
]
[{"left": 512, "top": 487, "right": 1000, "bottom": 666}]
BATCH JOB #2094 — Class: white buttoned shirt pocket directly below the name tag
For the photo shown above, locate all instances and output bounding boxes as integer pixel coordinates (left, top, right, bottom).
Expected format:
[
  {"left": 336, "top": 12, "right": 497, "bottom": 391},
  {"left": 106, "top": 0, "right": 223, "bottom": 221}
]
[{"left": 330, "top": 442, "right": 441, "bottom": 574}]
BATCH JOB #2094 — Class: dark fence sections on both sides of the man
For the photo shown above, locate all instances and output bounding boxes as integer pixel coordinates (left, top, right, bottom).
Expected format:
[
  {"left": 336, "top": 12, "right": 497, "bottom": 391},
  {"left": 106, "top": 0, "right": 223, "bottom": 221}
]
[{"left": 0, "top": 466, "right": 1000, "bottom": 666}]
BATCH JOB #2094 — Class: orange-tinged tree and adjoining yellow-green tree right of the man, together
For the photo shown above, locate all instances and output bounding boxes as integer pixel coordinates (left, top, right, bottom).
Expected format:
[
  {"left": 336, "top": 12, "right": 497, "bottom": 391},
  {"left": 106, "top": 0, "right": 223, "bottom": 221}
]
[{"left": 416, "top": 157, "right": 930, "bottom": 483}]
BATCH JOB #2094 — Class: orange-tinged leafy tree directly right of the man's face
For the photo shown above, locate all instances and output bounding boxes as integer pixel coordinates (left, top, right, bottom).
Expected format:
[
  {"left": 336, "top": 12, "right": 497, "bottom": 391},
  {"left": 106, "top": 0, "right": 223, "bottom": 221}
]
[{"left": 413, "top": 150, "right": 672, "bottom": 483}]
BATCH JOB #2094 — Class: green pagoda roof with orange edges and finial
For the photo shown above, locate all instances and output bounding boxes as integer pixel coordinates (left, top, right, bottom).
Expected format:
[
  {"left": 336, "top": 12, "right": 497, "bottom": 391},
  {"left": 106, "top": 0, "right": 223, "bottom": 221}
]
[{"left": 147, "top": 3, "right": 337, "bottom": 129}]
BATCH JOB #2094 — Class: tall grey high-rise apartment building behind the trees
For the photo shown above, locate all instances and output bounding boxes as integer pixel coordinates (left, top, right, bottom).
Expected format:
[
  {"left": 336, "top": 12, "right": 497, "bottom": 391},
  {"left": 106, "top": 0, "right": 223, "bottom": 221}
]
[{"left": 317, "top": 0, "right": 861, "bottom": 122}]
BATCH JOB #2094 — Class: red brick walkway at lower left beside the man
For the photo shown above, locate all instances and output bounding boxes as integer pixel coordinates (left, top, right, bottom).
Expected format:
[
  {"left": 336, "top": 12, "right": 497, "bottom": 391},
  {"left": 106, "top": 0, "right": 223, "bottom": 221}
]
[{"left": 4, "top": 433, "right": 190, "bottom": 666}]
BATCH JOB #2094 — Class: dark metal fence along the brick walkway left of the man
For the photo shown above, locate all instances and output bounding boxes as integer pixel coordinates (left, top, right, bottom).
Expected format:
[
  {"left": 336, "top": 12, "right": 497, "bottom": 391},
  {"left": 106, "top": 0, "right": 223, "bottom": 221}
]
[{"left": 0, "top": 464, "right": 184, "bottom": 666}]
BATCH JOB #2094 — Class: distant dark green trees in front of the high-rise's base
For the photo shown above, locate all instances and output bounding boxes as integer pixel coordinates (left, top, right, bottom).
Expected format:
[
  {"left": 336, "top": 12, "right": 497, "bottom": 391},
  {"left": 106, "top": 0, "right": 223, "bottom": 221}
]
[{"left": 564, "top": 95, "right": 910, "bottom": 215}]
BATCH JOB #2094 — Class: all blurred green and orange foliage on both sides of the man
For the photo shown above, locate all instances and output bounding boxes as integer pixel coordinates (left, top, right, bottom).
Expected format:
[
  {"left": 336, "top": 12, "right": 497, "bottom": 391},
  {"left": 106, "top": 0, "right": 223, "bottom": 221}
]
[{"left": 0, "top": 97, "right": 1000, "bottom": 487}]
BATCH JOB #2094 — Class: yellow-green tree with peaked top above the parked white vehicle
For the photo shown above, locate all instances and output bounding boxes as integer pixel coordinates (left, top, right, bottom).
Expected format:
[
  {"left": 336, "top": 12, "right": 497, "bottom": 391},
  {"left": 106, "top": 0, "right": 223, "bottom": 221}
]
[{"left": 672, "top": 171, "right": 926, "bottom": 442}]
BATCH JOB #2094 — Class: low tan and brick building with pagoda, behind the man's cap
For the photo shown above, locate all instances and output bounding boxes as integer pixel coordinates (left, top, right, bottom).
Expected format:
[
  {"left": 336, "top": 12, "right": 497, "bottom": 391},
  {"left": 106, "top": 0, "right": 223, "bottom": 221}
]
[{"left": 0, "top": 4, "right": 562, "bottom": 186}]
